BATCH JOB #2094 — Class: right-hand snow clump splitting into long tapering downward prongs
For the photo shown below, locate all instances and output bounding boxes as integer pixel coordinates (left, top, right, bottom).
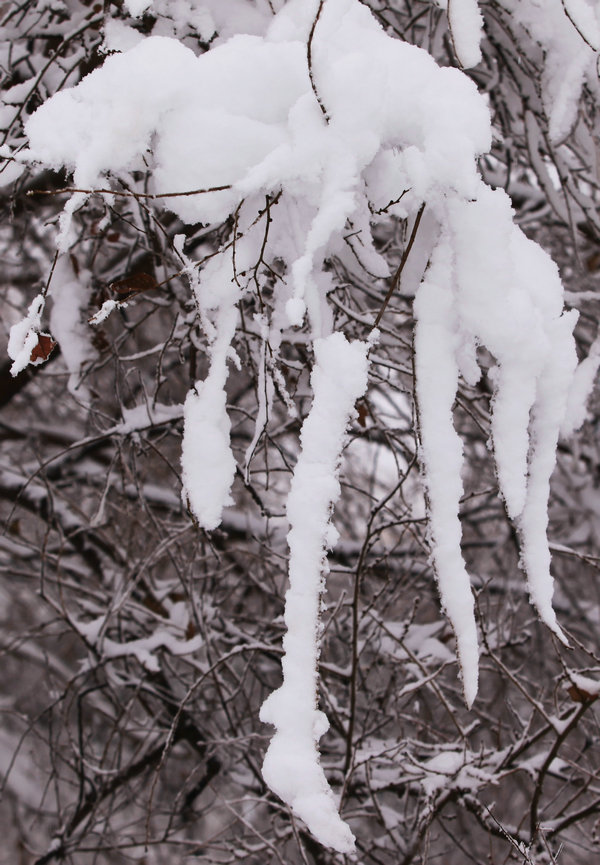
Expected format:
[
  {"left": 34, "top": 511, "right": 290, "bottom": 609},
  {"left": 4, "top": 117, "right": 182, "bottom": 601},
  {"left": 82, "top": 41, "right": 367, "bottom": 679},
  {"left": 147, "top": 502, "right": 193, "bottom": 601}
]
[{"left": 415, "top": 184, "right": 577, "bottom": 705}]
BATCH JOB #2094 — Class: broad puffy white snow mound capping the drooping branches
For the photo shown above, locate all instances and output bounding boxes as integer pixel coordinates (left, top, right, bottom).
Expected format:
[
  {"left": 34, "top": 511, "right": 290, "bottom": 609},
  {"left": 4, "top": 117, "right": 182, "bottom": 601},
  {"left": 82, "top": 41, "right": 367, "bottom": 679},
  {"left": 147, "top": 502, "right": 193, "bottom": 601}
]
[{"left": 26, "top": 0, "right": 491, "bottom": 312}]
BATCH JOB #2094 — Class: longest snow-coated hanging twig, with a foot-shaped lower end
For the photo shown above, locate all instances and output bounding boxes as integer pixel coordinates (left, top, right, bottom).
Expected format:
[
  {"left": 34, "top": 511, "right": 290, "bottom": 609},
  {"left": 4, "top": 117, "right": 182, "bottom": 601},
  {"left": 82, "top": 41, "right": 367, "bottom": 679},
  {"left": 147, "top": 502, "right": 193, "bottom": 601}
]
[{"left": 260, "top": 333, "right": 369, "bottom": 853}]
